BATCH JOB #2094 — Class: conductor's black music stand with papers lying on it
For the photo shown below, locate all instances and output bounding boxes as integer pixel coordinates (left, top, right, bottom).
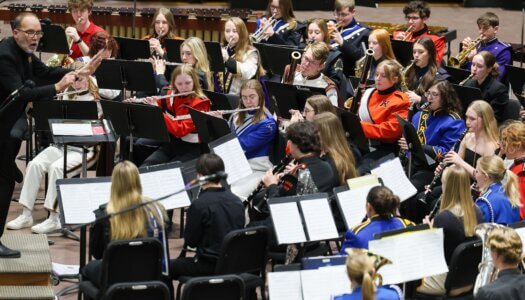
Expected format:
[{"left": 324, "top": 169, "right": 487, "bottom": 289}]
[{"left": 49, "top": 118, "right": 116, "bottom": 242}]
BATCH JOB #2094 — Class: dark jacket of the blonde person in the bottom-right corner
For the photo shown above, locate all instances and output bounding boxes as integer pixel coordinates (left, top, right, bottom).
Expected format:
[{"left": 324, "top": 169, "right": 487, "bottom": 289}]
[{"left": 476, "top": 269, "right": 525, "bottom": 300}]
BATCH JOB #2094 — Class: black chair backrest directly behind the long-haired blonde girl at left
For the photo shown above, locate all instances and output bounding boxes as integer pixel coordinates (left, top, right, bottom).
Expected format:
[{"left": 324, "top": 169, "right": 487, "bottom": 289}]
[{"left": 101, "top": 238, "right": 162, "bottom": 289}]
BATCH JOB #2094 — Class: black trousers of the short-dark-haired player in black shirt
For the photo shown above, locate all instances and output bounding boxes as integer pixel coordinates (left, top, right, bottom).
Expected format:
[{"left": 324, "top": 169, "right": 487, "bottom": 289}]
[{"left": 170, "top": 257, "right": 217, "bottom": 280}]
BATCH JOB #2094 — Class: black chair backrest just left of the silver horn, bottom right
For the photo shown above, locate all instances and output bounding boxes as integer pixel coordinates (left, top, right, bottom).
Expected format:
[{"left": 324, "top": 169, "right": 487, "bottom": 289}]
[{"left": 445, "top": 238, "right": 483, "bottom": 292}]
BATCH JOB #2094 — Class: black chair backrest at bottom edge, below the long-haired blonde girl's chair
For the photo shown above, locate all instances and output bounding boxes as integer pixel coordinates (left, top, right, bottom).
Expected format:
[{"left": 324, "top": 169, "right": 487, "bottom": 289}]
[{"left": 104, "top": 281, "right": 170, "bottom": 300}]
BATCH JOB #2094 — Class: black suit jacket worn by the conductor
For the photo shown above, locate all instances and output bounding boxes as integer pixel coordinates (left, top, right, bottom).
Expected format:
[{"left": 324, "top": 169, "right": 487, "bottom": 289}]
[{"left": 0, "top": 37, "right": 69, "bottom": 178}]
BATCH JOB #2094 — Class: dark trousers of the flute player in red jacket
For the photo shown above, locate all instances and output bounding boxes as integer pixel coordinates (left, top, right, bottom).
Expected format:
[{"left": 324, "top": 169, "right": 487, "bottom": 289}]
[{"left": 141, "top": 137, "right": 201, "bottom": 167}]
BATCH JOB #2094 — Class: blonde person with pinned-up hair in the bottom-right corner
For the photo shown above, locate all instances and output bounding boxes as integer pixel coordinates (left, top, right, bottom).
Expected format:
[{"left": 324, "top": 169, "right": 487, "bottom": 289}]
[{"left": 476, "top": 227, "right": 525, "bottom": 300}]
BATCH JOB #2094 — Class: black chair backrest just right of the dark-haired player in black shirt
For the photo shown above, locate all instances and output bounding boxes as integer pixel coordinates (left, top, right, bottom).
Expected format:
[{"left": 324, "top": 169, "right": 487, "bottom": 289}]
[{"left": 215, "top": 226, "right": 269, "bottom": 275}]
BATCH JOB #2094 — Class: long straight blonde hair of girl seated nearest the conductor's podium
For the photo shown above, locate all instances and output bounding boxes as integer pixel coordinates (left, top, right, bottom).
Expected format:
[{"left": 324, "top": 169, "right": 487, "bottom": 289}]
[{"left": 106, "top": 161, "right": 164, "bottom": 240}]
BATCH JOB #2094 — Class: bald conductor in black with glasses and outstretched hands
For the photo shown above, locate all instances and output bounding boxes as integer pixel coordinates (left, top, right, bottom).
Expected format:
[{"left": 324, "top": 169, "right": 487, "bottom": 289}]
[{"left": 0, "top": 13, "right": 100, "bottom": 258}]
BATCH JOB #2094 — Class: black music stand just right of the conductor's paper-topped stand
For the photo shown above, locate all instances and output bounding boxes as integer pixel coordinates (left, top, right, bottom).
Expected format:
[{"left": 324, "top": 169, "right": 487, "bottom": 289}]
[{"left": 100, "top": 100, "right": 170, "bottom": 160}]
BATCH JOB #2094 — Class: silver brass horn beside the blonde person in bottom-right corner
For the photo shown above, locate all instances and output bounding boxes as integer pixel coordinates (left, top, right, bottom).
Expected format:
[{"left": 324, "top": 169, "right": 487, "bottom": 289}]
[{"left": 474, "top": 223, "right": 504, "bottom": 296}]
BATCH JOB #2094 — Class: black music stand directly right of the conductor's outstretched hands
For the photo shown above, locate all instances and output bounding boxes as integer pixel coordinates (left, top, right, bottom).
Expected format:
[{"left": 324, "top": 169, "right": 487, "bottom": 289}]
[{"left": 95, "top": 59, "right": 157, "bottom": 97}]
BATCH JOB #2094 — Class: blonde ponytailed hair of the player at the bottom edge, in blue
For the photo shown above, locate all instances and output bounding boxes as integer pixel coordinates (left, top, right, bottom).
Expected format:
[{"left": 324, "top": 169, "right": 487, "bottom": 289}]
[{"left": 346, "top": 252, "right": 376, "bottom": 300}]
